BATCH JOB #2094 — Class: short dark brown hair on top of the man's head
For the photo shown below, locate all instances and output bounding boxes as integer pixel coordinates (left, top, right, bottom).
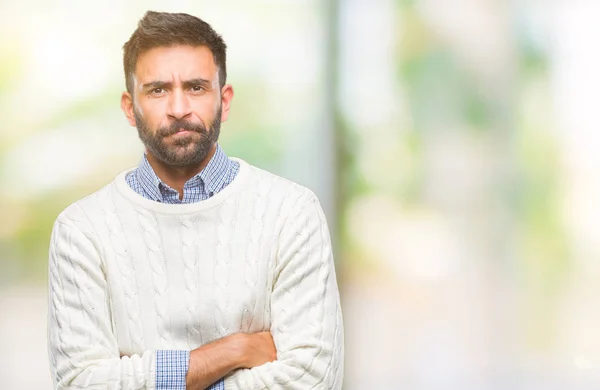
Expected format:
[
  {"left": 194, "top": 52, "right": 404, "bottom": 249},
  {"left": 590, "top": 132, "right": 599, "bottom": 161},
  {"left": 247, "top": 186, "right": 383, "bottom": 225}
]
[{"left": 123, "top": 11, "right": 227, "bottom": 93}]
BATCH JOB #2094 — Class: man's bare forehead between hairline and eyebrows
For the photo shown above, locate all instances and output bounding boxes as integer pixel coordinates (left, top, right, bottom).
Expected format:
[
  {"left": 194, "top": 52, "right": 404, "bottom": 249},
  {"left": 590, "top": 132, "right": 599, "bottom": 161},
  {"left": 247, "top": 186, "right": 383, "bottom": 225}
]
[{"left": 135, "top": 46, "right": 217, "bottom": 81}]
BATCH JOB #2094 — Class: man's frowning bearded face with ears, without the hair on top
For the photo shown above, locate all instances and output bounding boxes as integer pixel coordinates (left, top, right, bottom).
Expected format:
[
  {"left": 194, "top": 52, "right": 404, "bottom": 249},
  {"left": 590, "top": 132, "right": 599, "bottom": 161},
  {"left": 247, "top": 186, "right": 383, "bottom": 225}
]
[{"left": 122, "top": 46, "right": 233, "bottom": 167}]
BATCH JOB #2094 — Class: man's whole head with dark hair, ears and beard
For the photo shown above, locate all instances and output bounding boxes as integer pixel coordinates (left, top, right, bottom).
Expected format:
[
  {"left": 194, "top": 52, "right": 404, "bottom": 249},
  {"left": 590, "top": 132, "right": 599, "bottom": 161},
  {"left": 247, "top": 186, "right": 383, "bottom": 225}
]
[{"left": 121, "top": 11, "right": 233, "bottom": 167}]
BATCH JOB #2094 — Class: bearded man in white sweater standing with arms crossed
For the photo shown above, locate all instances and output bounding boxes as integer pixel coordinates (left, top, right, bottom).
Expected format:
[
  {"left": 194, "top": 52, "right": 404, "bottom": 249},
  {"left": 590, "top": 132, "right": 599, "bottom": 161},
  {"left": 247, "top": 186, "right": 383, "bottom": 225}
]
[{"left": 48, "top": 12, "right": 343, "bottom": 389}]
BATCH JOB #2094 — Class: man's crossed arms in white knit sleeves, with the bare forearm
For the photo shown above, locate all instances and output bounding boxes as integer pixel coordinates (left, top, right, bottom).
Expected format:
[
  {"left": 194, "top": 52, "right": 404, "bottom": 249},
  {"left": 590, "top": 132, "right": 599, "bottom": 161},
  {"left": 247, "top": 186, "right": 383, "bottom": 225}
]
[{"left": 48, "top": 197, "right": 343, "bottom": 390}]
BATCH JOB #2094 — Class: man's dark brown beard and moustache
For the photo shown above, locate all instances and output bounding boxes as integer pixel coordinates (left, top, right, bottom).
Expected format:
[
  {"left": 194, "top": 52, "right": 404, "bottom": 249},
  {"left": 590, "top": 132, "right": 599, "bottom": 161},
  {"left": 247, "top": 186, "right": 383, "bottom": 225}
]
[{"left": 134, "top": 106, "right": 221, "bottom": 167}]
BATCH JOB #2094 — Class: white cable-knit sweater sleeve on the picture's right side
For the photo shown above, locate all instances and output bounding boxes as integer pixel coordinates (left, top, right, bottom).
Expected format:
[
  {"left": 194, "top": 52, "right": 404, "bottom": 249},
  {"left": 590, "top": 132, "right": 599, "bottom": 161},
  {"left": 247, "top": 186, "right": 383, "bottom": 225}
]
[{"left": 225, "top": 195, "right": 344, "bottom": 390}]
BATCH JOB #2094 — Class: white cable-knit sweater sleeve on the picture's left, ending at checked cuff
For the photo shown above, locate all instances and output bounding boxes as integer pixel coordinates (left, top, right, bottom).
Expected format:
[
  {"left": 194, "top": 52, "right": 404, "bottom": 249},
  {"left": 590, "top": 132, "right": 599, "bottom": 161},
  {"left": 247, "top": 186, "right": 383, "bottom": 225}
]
[{"left": 48, "top": 216, "right": 156, "bottom": 389}]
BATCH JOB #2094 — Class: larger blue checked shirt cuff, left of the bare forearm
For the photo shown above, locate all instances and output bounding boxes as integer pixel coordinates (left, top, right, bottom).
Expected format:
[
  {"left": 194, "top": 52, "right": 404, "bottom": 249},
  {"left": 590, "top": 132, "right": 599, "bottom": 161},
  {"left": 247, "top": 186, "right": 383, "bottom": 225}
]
[{"left": 156, "top": 350, "right": 190, "bottom": 390}]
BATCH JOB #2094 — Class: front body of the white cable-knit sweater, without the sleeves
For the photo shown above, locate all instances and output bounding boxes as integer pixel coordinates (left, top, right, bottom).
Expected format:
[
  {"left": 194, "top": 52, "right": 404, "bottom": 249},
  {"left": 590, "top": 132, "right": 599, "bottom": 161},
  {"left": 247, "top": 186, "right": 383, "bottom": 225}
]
[{"left": 72, "top": 160, "right": 305, "bottom": 355}]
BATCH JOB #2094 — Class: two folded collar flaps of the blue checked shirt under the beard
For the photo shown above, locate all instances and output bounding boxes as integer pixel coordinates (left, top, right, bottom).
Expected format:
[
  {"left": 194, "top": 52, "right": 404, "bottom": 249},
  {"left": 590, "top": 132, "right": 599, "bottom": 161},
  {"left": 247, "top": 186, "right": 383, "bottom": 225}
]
[{"left": 136, "top": 144, "right": 231, "bottom": 202}]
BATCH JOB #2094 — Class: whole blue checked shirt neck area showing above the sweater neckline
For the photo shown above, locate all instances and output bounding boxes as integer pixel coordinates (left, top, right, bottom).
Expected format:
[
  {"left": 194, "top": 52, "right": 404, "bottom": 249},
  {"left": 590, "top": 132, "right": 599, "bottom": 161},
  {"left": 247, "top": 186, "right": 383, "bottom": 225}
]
[{"left": 126, "top": 144, "right": 240, "bottom": 204}]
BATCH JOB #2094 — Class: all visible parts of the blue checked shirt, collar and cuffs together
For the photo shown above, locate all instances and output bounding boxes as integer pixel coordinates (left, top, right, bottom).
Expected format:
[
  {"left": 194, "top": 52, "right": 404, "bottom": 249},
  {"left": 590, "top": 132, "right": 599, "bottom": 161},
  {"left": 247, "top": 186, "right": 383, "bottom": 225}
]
[{"left": 126, "top": 145, "right": 240, "bottom": 390}]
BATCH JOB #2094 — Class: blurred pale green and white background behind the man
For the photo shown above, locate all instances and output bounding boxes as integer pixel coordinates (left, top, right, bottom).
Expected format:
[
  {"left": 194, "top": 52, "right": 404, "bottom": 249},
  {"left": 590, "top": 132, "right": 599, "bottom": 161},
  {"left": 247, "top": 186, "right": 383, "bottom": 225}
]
[{"left": 0, "top": 0, "right": 600, "bottom": 390}]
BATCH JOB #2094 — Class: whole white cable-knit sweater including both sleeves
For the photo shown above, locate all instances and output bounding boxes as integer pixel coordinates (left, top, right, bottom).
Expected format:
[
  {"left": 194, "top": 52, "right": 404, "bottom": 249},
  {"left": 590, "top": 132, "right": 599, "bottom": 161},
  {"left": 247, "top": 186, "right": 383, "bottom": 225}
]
[{"left": 48, "top": 159, "right": 344, "bottom": 390}]
